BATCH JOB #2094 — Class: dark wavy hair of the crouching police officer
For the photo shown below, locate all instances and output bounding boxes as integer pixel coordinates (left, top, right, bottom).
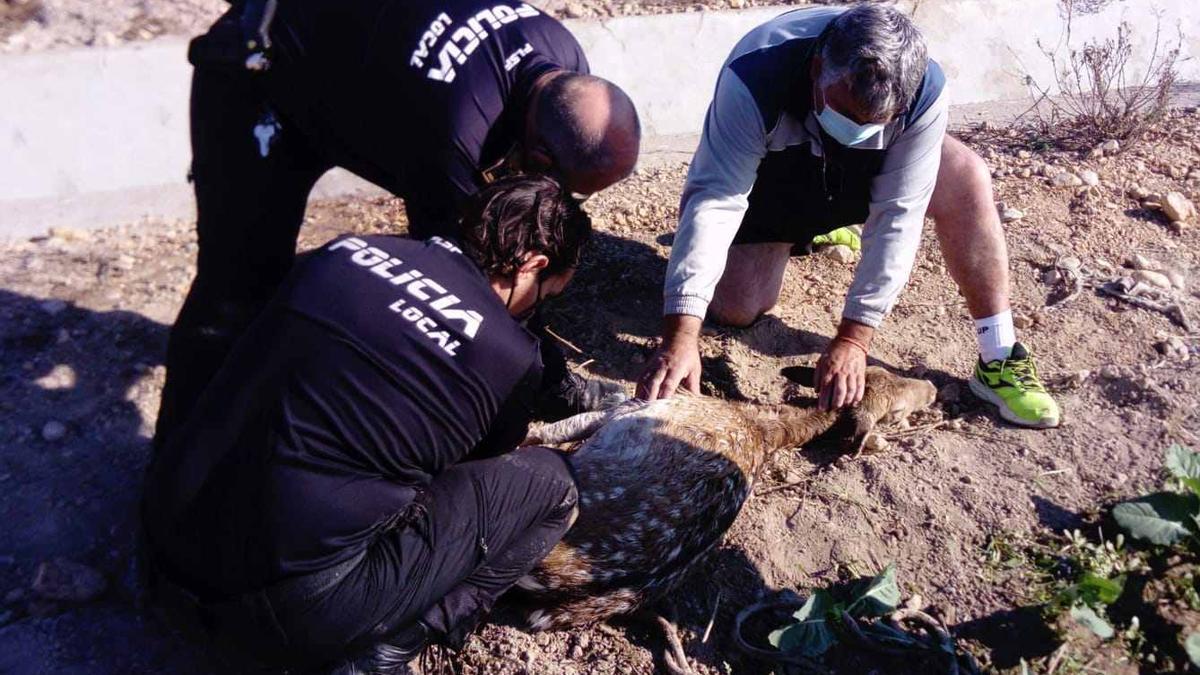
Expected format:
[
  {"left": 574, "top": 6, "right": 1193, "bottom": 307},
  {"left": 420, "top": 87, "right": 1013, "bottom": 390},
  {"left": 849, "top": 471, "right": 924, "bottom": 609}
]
[{"left": 461, "top": 175, "right": 592, "bottom": 277}]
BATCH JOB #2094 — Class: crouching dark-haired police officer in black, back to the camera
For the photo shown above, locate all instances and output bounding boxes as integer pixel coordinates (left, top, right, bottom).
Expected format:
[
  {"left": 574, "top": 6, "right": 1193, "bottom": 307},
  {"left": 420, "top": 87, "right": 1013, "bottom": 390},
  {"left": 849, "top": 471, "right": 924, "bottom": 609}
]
[{"left": 143, "top": 177, "right": 590, "bottom": 673}]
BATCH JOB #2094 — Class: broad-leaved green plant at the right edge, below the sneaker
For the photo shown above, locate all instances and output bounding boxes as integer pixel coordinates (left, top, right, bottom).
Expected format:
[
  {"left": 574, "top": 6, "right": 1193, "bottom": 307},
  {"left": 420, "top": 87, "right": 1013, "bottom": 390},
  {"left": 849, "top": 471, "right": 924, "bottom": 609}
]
[{"left": 1112, "top": 444, "right": 1200, "bottom": 546}]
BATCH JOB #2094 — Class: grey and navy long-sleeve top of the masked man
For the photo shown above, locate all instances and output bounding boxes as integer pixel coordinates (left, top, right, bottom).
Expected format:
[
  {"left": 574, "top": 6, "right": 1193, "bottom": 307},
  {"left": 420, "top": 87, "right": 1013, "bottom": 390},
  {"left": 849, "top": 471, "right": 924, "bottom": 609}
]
[{"left": 664, "top": 7, "right": 947, "bottom": 327}]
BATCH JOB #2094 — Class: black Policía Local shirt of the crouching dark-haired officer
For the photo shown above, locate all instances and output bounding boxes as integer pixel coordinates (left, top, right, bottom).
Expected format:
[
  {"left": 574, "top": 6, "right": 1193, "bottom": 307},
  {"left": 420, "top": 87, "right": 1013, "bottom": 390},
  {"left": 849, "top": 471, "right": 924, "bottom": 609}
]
[{"left": 143, "top": 237, "right": 541, "bottom": 598}]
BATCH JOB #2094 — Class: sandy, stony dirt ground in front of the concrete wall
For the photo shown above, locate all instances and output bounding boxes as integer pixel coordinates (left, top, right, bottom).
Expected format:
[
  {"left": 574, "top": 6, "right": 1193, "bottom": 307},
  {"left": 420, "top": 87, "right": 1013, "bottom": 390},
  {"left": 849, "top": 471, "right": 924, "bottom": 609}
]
[{"left": 0, "top": 102, "right": 1200, "bottom": 675}]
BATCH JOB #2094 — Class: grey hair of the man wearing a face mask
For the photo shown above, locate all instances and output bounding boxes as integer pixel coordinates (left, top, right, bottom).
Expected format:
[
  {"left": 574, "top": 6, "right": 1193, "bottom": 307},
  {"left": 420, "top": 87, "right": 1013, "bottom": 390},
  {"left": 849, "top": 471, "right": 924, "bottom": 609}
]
[{"left": 820, "top": 2, "right": 928, "bottom": 120}]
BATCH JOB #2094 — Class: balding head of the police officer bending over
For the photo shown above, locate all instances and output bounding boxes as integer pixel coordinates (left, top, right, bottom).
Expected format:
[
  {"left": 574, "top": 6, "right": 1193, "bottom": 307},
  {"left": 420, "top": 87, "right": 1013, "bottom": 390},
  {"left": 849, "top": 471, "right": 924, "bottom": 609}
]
[{"left": 536, "top": 72, "right": 642, "bottom": 178}]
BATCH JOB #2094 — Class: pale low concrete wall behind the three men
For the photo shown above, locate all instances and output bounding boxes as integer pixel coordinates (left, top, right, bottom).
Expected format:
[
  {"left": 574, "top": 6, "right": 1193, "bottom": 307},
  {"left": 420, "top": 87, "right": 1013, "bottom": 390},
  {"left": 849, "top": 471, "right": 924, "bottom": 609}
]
[{"left": 0, "top": 0, "right": 1200, "bottom": 235}]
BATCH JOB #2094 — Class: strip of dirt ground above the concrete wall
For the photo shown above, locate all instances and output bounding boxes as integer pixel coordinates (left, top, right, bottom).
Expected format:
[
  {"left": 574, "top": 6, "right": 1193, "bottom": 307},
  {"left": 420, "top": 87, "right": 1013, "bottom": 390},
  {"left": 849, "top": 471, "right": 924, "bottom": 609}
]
[{"left": 0, "top": 0, "right": 809, "bottom": 54}]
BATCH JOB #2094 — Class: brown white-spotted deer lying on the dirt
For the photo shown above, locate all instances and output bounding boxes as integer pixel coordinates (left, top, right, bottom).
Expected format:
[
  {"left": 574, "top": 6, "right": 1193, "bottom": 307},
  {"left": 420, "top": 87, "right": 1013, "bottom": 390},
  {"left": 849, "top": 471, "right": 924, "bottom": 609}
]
[{"left": 518, "top": 368, "right": 936, "bottom": 629}]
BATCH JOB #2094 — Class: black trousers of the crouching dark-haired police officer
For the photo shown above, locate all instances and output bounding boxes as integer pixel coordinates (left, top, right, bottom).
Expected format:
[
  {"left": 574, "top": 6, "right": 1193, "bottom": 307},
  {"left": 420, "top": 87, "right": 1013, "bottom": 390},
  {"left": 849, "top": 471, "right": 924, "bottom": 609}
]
[{"left": 151, "top": 447, "right": 578, "bottom": 673}]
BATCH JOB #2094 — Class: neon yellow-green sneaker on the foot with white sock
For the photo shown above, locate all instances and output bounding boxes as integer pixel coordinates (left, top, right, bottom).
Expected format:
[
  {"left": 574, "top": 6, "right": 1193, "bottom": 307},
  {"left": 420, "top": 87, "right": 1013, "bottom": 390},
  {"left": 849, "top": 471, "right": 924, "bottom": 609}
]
[{"left": 971, "top": 342, "right": 1058, "bottom": 429}]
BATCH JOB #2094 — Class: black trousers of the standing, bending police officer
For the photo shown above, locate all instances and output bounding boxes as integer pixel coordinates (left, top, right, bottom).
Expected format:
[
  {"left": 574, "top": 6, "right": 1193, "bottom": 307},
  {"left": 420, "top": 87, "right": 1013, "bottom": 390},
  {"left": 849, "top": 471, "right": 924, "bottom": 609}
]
[{"left": 155, "top": 60, "right": 332, "bottom": 446}]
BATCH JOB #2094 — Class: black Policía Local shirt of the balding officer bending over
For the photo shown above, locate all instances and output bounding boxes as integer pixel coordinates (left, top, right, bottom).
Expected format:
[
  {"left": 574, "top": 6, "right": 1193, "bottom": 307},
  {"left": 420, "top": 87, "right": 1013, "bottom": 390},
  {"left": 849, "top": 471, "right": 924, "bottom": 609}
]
[{"left": 268, "top": 0, "right": 588, "bottom": 238}]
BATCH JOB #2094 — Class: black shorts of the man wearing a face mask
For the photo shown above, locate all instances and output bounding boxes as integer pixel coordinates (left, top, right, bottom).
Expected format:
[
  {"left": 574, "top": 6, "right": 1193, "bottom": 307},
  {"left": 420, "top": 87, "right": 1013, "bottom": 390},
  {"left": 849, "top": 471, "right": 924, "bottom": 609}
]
[{"left": 733, "top": 144, "right": 882, "bottom": 245}]
